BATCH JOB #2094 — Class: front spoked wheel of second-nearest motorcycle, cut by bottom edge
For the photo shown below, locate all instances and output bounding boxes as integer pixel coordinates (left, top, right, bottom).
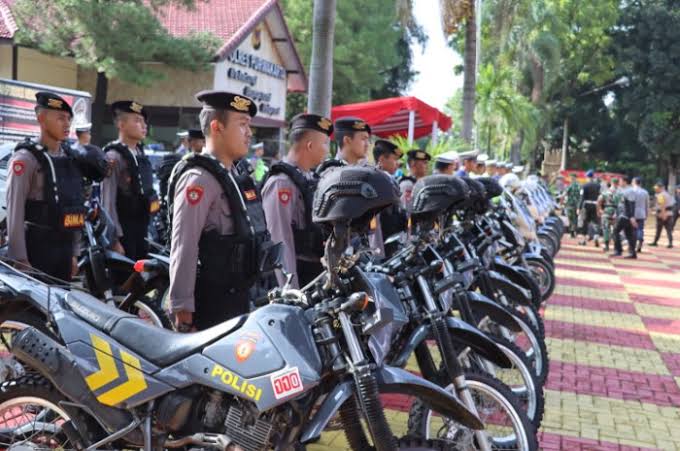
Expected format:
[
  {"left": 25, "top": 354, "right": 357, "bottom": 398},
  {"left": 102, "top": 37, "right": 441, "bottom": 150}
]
[{"left": 409, "top": 372, "right": 538, "bottom": 451}]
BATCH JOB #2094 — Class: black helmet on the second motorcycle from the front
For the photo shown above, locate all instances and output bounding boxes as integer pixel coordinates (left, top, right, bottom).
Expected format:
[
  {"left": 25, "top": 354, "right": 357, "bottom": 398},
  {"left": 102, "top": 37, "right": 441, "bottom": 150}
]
[{"left": 410, "top": 174, "right": 470, "bottom": 219}]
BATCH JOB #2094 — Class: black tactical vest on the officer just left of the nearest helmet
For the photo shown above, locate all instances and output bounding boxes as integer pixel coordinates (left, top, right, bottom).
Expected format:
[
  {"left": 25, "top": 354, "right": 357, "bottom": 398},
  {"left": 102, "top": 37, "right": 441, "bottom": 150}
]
[{"left": 265, "top": 161, "right": 324, "bottom": 260}]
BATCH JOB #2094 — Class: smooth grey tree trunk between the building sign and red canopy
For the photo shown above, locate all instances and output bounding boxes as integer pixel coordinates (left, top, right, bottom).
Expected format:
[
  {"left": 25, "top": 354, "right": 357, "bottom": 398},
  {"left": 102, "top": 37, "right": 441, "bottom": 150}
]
[{"left": 307, "top": 0, "right": 336, "bottom": 117}]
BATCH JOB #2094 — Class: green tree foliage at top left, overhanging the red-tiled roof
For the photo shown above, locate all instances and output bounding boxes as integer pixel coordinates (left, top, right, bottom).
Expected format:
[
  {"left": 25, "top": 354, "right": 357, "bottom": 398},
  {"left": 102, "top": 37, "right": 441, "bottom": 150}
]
[{"left": 13, "top": 0, "right": 219, "bottom": 85}]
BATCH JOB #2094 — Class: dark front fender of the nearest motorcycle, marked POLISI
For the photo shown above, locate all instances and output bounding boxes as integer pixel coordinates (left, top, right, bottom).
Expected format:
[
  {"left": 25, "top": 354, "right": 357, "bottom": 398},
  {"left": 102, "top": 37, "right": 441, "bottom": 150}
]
[{"left": 376, "top": 366, "right": 484, "bottom": 430}]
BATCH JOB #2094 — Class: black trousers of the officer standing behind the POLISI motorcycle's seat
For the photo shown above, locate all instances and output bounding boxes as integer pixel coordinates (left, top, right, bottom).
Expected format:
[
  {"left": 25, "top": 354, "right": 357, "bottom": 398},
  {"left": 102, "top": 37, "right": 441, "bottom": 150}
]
[{"left": 194, "top": 274, "right": 250, "bottom": 330}]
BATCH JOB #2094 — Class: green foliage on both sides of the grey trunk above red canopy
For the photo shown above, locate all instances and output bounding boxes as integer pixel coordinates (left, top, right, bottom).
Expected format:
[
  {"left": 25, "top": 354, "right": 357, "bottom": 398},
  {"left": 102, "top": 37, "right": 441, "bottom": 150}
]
[{"left": 281, "top": 0, "right": 425, "bottom": 109}]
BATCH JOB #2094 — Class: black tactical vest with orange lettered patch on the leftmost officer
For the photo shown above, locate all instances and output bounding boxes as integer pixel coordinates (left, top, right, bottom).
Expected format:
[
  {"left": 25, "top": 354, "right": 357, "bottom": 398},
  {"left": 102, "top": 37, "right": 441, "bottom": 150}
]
[{"left": 14, "top": 139, "right": 86, "bottom": 233}]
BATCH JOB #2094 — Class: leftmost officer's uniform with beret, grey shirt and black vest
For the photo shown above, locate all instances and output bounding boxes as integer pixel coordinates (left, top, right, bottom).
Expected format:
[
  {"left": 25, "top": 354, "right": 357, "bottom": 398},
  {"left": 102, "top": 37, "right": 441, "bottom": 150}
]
[{"left": 7, "top": 92, "right": 86, "bottom": 281}]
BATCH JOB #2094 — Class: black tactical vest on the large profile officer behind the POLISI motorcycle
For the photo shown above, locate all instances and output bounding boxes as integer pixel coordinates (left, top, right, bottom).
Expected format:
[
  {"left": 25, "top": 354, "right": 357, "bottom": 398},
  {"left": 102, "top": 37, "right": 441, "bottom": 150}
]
[{"left": 168, "top": 154, "right": 270, "bottom": 290}]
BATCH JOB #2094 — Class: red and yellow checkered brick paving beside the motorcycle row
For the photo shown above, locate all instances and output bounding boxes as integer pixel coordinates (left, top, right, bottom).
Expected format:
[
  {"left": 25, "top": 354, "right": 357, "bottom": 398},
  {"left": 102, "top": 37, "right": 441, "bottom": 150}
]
[{"left": 309, "top": 228, "right": 680, "bottom": 451}]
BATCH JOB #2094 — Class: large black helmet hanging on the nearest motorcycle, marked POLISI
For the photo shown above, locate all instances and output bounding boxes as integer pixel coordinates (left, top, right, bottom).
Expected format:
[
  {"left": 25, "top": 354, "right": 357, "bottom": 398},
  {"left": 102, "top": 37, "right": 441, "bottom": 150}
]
[{"left": 312, "top": 166, "right": 399, "bottom": 228}]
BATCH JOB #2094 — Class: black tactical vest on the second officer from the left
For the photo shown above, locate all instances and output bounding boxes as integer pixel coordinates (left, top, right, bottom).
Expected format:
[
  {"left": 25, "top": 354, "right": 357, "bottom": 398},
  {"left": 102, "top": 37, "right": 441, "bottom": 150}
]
[{"left": 104, "top": 141, "right": 160, "bottom": 221}]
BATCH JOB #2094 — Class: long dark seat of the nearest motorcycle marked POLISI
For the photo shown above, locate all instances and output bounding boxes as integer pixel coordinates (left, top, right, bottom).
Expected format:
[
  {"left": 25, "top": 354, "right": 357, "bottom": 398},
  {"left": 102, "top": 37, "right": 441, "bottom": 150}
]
[{"left": 111, "top": 315, "right": 248, "bottom": 368}]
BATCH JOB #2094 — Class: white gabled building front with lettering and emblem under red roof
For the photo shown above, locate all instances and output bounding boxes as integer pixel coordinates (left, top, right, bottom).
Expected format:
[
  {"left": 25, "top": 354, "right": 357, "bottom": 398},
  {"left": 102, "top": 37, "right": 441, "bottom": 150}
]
[{"left": 215, "top": 24, "right": 287, "bottom": 121}]
